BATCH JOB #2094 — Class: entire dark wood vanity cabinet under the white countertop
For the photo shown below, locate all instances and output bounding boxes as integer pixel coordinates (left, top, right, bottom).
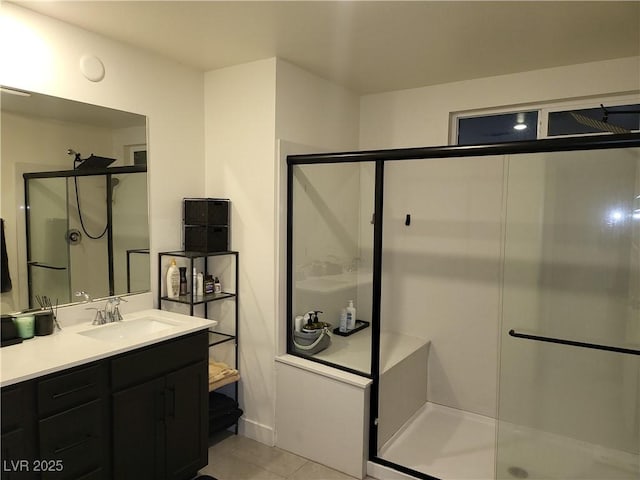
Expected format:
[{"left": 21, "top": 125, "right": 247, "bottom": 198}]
[{"left": 1, "top": 330, "right": 208, "bottom": 480}]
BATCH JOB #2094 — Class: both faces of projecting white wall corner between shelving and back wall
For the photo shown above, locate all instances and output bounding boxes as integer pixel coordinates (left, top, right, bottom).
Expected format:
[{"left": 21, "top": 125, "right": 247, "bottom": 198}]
[{"left": 205, "top": 58, "right": 359, "bottom": 444}]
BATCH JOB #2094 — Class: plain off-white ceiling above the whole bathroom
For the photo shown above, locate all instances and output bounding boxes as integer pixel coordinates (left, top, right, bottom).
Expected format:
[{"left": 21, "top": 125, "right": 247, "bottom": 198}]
[{"left": 13, "top": 0, "right": 640, "bottom": 94}]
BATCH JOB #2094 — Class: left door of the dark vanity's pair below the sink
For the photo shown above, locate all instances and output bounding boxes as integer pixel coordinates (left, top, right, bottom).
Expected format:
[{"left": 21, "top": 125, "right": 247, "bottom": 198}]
[{"left": 112, "top": 378, "right": 165, "bottom": 480}]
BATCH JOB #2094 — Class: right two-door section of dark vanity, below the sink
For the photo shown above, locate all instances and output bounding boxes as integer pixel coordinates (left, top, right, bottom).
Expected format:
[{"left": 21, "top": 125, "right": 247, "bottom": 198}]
[{"left": 111, "top": 331, "right": 208, "bottom": 480}]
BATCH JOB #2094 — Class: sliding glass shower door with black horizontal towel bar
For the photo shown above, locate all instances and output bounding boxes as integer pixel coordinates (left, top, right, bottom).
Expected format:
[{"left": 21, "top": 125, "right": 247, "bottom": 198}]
[{"left": 496, "top": 149, "right": 640, "bottom": 480}]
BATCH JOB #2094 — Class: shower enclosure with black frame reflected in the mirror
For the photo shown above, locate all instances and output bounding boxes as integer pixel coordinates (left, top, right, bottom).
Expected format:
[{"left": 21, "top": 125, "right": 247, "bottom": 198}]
[{"left": 23, "top": 165, "right": 149, "bottom": 308}]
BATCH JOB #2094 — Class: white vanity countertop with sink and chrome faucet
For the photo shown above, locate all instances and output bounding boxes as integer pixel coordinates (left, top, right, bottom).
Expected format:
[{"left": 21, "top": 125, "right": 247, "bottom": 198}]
[{"left": 0, "top": 309, "right": 218, "bottom": 387}]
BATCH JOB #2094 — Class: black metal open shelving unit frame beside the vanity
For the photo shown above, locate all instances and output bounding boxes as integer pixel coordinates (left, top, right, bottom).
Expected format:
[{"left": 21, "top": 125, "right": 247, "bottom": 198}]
[{"left": 158, "top": 250, "right": 240, "bottom": 433}]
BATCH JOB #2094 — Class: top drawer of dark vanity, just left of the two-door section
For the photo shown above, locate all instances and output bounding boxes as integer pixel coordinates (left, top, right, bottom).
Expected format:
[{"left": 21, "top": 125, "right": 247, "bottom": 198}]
[{"left": 38, "top": 365, "right": 106, "bottom": 417}]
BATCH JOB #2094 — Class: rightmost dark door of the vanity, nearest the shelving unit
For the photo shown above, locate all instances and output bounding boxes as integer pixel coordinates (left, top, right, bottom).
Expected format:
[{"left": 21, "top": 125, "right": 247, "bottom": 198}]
[{"left": 166, "top": 361, "right": 208, "bottom": 480}]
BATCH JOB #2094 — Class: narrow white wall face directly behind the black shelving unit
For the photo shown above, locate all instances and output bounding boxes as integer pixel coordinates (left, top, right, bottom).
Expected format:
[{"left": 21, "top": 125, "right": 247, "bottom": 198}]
[{"left": 205, "top": 59, "right": 276, "bottom": 444}]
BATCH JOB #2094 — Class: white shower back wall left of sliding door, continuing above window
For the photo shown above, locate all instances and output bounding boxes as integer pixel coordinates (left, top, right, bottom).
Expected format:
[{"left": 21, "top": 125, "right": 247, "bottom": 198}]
[{"left": 360, "top": 57, "right": 640, "bottom": 415}]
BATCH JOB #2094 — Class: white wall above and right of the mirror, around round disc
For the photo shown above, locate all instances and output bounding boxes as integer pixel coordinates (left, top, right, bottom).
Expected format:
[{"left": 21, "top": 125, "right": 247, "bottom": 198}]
[{"left": 0, "top": 2, "right": 204, "bottom": 310}]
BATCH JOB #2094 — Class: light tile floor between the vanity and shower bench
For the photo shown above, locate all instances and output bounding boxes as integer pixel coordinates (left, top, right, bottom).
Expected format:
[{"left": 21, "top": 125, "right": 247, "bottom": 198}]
[{"left": 200, "top": 434, "right": 373, "bottom": 480}]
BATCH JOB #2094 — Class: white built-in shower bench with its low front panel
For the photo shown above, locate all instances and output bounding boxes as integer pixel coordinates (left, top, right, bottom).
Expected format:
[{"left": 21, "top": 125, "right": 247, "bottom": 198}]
[{"left": 276, "top": 328, "right": 429, "bottom": 478}]
